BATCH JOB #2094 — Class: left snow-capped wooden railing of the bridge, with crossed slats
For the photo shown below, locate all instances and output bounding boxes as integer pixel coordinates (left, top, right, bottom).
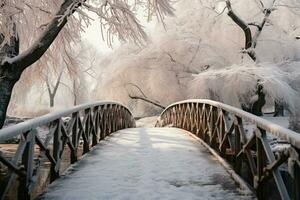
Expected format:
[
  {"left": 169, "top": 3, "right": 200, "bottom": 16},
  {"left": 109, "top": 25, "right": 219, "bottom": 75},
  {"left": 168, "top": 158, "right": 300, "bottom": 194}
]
[{"left": 0, "top": 102, "right": 135, "bottom": 199}]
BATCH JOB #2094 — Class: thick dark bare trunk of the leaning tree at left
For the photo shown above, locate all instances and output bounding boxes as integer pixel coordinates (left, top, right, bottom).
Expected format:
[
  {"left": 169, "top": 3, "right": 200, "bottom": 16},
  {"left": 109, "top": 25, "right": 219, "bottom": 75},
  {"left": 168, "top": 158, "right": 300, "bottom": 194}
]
[{"left": 0, "top": 0, "right": 81, "bottom": 128}]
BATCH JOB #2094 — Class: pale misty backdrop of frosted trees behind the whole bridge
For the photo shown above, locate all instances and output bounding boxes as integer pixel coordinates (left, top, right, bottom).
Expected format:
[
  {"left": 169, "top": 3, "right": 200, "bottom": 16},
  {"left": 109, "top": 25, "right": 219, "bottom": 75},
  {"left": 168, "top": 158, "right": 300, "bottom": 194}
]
[{"left": 8, "top": 0, "right": 300, "bottom": 117}]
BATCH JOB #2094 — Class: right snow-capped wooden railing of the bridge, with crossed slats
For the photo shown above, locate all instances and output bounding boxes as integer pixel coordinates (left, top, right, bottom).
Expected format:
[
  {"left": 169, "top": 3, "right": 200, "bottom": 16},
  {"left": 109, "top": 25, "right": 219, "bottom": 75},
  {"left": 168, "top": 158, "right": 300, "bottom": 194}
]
[{"left": 156, "top": 100, "right": 300, "bottom": 200}]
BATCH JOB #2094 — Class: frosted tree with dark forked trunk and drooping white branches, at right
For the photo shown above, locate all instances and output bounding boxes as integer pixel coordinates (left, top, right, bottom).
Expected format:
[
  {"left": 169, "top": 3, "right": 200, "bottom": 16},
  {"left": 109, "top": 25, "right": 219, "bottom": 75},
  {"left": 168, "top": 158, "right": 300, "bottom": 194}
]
[{"left": 190, "top": 0, "right": 300, "bottom": 115}]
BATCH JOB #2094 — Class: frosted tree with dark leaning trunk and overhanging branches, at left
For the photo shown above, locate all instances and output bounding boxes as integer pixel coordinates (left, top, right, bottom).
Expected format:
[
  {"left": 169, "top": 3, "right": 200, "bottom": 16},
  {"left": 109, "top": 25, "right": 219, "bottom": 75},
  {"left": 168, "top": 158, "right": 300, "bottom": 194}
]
[{"left": 0, "top": 0, "right": 173, "bottom": 127}]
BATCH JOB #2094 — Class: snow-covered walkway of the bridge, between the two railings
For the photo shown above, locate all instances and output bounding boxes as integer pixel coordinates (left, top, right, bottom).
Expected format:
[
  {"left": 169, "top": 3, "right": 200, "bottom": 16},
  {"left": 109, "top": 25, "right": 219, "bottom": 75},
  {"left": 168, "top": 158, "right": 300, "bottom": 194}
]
[{"left": 42, "top": 128, "right": 254, "bottom": 200}]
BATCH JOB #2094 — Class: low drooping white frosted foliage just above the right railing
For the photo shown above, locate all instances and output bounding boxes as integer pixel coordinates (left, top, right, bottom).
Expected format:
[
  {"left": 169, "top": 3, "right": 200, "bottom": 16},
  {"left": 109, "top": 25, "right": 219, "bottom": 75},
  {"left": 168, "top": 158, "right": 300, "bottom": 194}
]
[{"left": 189, "top": 63, "right": 300, "bottom": 111}]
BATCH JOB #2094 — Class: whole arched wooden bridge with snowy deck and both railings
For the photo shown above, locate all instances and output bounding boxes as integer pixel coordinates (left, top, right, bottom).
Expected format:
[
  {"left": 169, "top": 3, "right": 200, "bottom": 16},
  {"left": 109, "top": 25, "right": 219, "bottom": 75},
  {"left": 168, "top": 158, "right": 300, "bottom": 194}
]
[{"left": 0, "top": 100, "right": 300, "bottom": 200}]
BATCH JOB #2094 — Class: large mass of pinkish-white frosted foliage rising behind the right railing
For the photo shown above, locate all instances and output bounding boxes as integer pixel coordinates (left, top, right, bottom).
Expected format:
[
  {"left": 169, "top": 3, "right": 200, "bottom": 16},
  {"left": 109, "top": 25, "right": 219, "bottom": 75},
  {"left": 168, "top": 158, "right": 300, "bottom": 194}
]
[{"left": 94, "top": 0, "right": 300, "bottom": 121}]
